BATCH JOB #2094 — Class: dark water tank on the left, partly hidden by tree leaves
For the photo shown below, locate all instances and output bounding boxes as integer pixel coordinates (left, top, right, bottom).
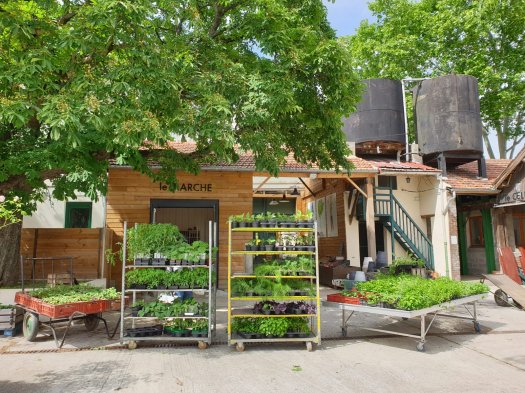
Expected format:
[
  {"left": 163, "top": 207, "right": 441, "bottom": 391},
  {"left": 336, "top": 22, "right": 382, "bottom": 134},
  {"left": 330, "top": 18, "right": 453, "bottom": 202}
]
[{"left": 343, "top": 79, "right": 405, "bottom": 144}]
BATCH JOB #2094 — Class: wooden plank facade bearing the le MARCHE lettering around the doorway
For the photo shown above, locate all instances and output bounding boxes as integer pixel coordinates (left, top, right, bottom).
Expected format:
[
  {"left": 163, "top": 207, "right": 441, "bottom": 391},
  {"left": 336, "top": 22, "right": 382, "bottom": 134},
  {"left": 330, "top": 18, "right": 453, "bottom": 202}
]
[{"left": 106, "top": 168, "right": 253, "bottom": 288}]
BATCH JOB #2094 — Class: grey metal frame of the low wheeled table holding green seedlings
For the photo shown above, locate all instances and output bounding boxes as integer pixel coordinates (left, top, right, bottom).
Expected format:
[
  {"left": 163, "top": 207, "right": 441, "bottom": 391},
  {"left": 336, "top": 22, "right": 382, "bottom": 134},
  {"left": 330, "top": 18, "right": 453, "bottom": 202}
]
[{"left": 322, "top": 294, "right": 486, "bottom": 351}]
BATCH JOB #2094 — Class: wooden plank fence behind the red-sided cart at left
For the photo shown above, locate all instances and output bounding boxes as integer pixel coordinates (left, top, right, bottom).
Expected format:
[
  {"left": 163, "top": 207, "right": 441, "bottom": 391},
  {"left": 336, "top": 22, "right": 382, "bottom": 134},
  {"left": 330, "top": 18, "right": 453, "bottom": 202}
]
[{"left": 20, "top": 228, "right": 103, "bottom": 279}]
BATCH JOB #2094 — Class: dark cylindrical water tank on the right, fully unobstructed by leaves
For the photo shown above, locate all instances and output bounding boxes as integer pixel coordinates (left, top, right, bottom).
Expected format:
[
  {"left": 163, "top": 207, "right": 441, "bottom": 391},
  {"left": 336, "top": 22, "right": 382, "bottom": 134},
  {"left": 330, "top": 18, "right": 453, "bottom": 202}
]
[{"left": 413, "top": 75, "right": 483, "bottom": 155}]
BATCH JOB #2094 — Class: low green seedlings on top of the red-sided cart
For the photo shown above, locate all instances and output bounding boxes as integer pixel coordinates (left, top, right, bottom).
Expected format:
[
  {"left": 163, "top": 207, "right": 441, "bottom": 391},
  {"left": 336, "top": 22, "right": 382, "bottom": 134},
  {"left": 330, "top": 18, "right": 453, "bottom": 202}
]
[{"left": 30, "top": 284, "right": 120, "bottom": 304}]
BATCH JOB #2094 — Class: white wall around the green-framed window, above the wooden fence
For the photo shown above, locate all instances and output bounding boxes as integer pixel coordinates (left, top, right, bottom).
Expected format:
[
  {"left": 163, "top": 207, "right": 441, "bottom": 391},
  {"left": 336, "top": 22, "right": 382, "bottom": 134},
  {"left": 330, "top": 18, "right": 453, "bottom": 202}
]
[{"left": 22, "top": 191, "right": 105, "bottom": 228}]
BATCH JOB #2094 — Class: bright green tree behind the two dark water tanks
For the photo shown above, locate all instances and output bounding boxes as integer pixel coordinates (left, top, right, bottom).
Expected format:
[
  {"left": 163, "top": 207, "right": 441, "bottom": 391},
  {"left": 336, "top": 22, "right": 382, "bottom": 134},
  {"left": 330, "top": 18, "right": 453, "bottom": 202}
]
[{"left": 347, "top": 0, "right": 525, "bottom": 158}]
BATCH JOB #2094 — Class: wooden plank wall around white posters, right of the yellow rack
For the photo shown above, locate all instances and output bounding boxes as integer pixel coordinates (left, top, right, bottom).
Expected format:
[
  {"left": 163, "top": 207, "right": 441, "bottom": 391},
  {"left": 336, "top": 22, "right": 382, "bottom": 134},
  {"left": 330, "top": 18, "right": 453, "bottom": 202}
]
[{"left": 306, "top": 179, "right": 348, "bottom": 259}]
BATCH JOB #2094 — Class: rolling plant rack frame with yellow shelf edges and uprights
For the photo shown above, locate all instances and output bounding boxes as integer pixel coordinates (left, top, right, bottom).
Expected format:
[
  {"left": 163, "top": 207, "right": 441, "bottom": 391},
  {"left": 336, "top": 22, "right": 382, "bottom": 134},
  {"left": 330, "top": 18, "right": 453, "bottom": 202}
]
[{"left": 228, "top": 220, "right": 321, "bottom": 352}]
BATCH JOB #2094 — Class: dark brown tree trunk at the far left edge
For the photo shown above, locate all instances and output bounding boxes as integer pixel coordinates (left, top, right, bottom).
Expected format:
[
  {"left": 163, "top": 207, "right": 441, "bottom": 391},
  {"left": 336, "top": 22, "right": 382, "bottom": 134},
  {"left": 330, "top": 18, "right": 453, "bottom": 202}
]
[{"left": 0, "top": 221, "right": 22, "bottom": 286}]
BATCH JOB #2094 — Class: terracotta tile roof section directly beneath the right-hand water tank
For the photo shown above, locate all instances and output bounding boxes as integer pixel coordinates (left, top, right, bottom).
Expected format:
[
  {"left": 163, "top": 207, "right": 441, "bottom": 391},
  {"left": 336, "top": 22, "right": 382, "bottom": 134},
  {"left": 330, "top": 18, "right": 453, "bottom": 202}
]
[{"left": 446, "top": 160, "right": 512, "bottom": 192}]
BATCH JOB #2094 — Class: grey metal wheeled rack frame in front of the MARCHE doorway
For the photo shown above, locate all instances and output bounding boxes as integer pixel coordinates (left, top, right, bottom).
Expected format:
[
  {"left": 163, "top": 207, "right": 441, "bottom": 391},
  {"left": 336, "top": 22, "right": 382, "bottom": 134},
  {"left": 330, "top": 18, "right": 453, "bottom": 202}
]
[{"left": 120, "top": 221, "right": 217, "bottom": 349}]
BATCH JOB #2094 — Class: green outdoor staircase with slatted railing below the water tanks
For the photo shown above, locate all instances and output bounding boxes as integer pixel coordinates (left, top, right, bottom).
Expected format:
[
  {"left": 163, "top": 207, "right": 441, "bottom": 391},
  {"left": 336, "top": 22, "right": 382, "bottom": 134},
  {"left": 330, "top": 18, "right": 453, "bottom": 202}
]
[{"left": 374, "top": 187, "right": 434, "bottom": 269}]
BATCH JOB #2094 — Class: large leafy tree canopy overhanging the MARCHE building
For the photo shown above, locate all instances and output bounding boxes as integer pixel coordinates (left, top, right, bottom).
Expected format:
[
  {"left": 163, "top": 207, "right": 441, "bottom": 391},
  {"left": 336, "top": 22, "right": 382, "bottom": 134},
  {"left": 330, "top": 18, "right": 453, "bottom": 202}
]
[{"left": 0, "top": 0, "right": 359, "bottom": 280}]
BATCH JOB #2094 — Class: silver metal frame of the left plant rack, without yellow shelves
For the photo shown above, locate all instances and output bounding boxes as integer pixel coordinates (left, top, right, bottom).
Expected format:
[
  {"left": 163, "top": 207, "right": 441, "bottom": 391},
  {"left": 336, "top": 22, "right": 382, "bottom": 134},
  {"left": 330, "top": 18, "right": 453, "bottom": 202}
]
[{"left": 120, "top": 221, "right": 217, "bottom": 349}]
